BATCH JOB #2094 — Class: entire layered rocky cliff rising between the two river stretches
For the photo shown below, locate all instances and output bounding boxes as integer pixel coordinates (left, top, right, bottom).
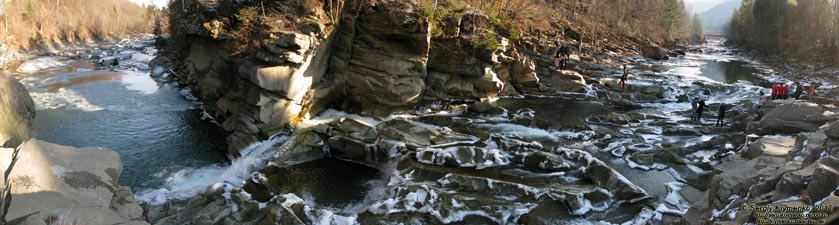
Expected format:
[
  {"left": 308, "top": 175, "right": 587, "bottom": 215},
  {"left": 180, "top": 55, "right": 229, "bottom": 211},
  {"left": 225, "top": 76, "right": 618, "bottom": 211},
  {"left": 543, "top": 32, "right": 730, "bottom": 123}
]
[{"left": 165, "top": 1, "right": 539, "bottom": 154}]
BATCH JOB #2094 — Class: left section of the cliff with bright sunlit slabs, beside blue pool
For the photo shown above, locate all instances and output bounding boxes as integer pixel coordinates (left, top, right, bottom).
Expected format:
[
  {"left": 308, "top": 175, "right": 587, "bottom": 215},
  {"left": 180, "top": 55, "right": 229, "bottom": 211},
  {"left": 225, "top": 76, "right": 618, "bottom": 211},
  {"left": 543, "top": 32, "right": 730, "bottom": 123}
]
[{"left": 167, "top": 1, "right": 343, "bottom": 155}]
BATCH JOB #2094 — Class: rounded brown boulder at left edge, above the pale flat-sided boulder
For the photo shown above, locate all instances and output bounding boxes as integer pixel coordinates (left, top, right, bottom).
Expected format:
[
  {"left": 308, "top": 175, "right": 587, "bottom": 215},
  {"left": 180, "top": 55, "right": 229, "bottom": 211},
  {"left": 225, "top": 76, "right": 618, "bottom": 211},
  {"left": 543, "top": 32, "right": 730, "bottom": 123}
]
[{"left": 0, "top": 75, "right": 35, "bottom": 147}]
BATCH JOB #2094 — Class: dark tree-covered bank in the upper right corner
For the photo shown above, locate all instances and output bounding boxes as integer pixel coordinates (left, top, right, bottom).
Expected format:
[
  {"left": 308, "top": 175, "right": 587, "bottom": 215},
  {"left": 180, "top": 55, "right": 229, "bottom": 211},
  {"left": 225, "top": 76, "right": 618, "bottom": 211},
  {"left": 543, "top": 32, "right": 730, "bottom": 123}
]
[{"left": 726, "top": 0, "right": 839, "bottom": 63}]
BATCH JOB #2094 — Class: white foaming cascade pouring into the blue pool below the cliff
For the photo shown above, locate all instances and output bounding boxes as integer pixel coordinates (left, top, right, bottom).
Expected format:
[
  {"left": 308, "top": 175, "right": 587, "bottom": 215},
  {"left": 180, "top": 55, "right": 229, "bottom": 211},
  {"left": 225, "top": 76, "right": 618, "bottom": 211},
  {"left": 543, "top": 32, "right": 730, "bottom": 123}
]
[{"left": 135, "top": 136, "right": 289, "bottom": 205}]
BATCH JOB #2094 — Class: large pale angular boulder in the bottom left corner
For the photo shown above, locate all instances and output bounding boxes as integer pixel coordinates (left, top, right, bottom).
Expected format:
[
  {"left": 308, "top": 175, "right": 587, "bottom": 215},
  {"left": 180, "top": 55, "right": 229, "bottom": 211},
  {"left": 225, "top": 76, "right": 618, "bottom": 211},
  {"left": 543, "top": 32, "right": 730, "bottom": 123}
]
[{"left": 0, "top": 139, "right": 147, "bottom": 224}]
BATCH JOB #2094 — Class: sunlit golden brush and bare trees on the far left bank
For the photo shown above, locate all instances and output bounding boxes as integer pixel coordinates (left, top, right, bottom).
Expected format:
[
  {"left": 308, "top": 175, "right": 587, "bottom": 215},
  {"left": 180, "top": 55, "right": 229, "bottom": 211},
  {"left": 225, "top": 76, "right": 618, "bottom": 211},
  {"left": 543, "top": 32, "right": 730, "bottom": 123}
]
[{"left": 0, "top": 0, "right": 158, "bottom": 50}]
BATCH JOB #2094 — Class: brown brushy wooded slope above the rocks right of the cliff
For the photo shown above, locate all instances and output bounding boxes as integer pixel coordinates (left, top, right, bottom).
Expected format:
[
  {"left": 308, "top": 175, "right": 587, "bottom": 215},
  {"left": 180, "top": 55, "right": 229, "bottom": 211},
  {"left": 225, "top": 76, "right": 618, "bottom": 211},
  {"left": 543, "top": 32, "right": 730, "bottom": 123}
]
[{"left": 420, "top": 0, "right": 696, "bottom": 49}]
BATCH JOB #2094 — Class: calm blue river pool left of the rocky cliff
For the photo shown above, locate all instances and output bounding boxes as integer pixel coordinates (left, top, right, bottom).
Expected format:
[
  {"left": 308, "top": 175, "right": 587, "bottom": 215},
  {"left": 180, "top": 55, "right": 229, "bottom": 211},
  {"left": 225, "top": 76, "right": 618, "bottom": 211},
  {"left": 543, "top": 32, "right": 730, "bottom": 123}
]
[{"left": 19, "top": 63, "right": 227, "bottom": 191}]
